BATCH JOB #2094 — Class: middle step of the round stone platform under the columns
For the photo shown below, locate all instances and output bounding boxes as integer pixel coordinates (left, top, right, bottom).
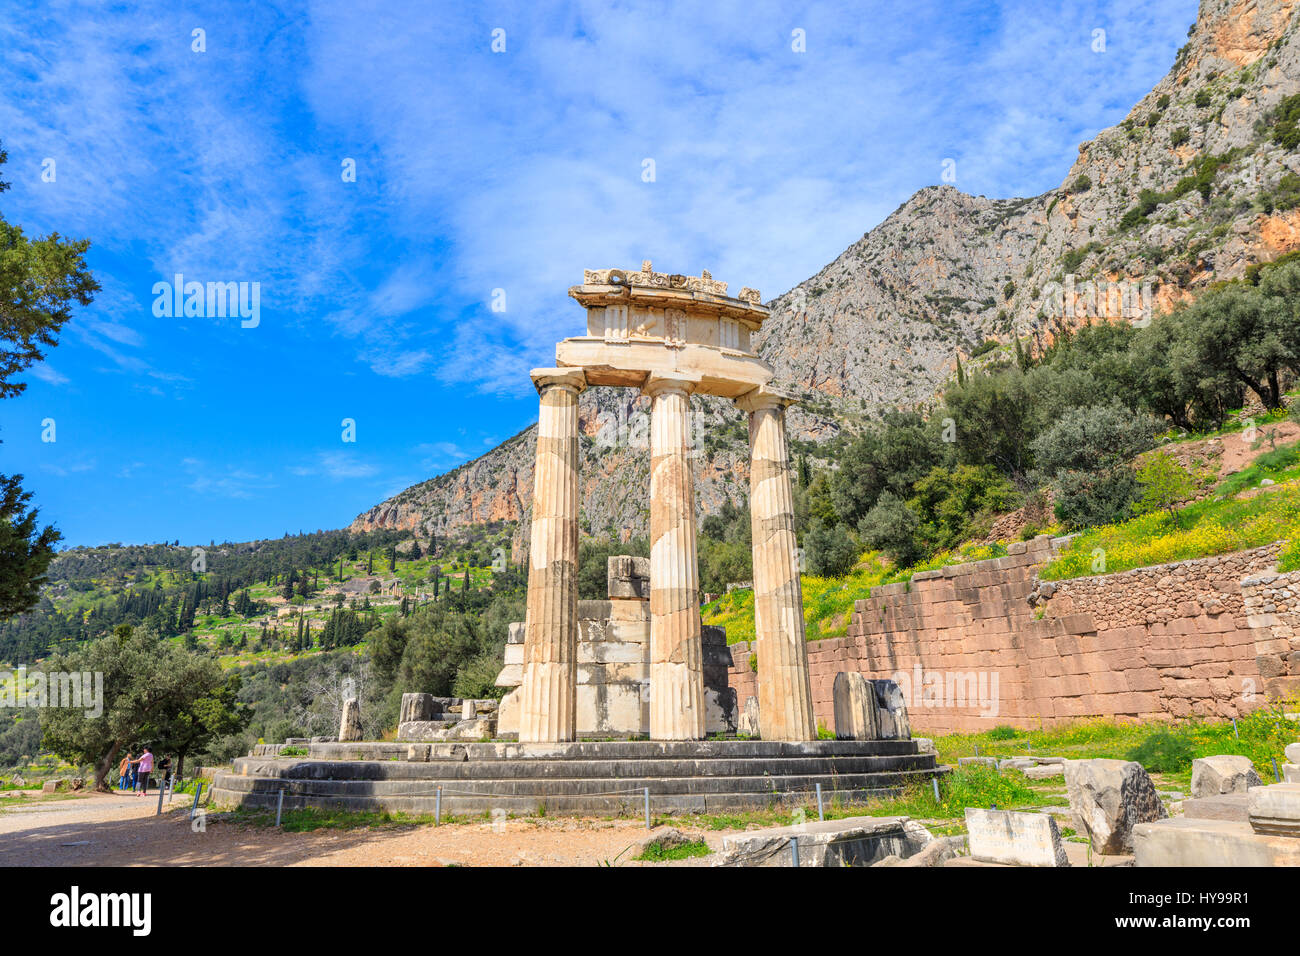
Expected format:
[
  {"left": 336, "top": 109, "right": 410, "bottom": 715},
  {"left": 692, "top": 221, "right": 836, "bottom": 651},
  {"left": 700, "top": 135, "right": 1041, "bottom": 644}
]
[{"left": 233, "top": 753, "right": 936, "bottom": 783}]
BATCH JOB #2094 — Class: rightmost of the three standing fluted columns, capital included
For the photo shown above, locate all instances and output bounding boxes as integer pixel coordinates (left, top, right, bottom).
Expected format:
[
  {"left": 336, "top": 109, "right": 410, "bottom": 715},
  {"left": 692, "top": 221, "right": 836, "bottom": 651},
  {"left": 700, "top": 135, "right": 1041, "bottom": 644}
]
[{"left": 736, "top": 388, "right": 816, "bottom": 740}]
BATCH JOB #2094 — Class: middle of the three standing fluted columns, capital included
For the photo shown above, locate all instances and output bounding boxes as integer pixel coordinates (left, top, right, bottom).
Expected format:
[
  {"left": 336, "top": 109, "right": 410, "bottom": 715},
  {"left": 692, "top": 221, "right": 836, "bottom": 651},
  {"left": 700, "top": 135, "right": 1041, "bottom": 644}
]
[{"left": 645, "top": 376, "right": 705, "bottom": 740}]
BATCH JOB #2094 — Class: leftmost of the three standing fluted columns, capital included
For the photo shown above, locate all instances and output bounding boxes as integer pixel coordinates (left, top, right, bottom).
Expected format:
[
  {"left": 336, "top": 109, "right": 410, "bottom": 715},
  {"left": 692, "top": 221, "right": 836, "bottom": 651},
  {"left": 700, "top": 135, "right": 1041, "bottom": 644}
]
[{"left": 519, "top": 368, "right": 586, "bottom": 743}]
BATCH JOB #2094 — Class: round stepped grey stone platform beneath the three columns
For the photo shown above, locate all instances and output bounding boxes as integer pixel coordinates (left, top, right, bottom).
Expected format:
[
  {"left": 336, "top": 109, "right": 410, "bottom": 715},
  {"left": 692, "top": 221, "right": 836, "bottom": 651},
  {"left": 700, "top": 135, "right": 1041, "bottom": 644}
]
[{"left": 212, "top": 739, "right": 948, "bottom": 814}]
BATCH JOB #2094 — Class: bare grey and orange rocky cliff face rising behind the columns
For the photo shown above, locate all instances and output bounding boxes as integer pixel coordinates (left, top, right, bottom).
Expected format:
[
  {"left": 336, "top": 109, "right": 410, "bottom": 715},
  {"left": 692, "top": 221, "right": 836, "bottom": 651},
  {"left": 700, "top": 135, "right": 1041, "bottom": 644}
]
[{"left": 351, "top": 0, "right": 1300, "bottom": 548}]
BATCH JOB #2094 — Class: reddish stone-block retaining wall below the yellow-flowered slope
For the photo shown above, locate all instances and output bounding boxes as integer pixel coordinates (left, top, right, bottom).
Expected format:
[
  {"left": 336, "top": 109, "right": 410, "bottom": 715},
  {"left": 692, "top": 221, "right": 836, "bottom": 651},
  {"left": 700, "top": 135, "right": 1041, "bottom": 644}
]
[{"left": 728, "top": 536, "right": 1284, "bottom": 734}]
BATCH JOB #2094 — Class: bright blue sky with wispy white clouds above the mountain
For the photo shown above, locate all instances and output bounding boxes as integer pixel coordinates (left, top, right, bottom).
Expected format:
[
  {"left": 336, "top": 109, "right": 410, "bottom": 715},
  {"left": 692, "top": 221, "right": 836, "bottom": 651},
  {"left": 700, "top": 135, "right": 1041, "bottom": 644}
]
[{"left": 0, "top": 0, "right": 1196, "bottom": 545}]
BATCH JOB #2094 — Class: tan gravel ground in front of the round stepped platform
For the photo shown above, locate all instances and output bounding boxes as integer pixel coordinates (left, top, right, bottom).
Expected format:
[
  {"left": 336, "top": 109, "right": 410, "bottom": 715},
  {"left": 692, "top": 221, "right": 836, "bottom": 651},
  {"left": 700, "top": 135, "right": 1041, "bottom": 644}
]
[{"left": 0, "top": 793, "right": 724, "bottom": 866}]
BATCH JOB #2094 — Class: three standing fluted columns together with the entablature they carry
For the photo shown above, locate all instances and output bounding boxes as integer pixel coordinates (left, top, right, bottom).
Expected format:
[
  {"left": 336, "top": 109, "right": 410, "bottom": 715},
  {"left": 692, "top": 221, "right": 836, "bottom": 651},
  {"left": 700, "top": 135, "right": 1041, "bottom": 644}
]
[{"left": 512, "top": 261, "right": 816, "bottom": 743}]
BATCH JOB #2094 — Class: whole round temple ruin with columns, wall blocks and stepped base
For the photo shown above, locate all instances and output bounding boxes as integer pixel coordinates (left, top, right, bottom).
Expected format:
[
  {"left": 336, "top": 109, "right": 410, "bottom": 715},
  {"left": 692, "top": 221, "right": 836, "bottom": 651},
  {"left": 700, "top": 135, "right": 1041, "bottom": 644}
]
[{"left": 212, "top": 263, "right": 946, "bottom": 822}]
